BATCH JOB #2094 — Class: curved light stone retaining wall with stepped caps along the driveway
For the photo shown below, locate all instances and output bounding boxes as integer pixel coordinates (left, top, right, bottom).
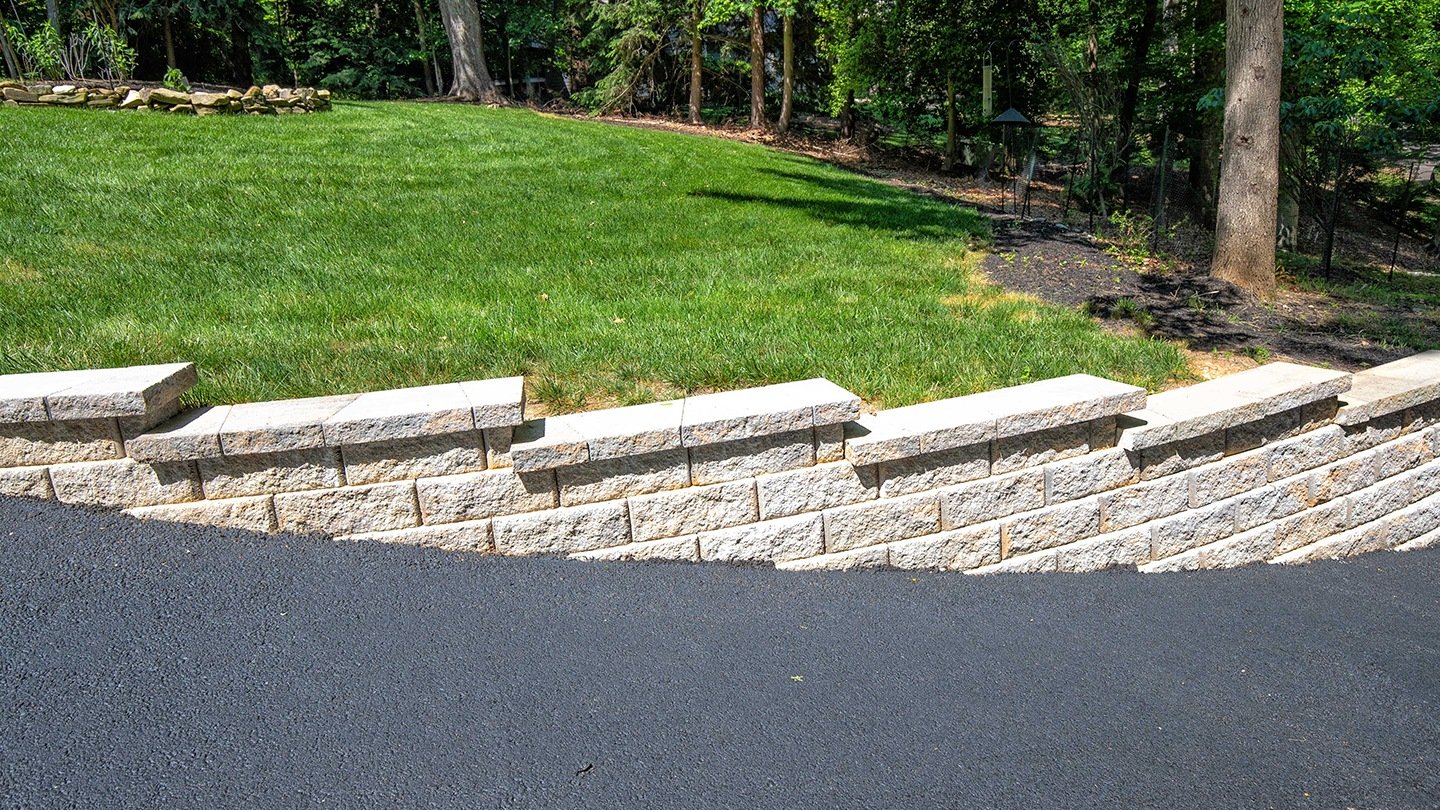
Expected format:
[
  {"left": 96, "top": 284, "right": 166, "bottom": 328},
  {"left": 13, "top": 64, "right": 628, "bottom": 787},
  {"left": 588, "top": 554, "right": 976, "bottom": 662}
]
[{"left": 0, "top": 352, "right": 1440, "bottom": 574}]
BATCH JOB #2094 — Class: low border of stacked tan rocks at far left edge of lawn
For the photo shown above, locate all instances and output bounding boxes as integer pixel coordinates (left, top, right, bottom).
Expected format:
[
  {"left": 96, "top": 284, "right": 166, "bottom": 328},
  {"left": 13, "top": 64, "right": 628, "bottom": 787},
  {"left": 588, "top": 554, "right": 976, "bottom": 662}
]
[{"left": 0, "top": 79, "right": 330, "bottom": 115}]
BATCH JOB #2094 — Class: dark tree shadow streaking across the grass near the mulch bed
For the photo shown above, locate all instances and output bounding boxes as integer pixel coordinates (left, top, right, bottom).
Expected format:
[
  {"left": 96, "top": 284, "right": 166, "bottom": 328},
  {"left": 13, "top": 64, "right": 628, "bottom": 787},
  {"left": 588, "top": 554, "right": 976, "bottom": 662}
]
[{"left": 690, "top": 169, "right": 986, "bottom": 242}]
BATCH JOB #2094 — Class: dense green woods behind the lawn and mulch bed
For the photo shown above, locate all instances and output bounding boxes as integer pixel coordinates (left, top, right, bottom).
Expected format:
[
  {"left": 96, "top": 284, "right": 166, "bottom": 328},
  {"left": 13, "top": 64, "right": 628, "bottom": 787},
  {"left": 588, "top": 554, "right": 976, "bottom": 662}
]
[{"left": 8, "top": 0, "right": 1440, "bottom": 291}]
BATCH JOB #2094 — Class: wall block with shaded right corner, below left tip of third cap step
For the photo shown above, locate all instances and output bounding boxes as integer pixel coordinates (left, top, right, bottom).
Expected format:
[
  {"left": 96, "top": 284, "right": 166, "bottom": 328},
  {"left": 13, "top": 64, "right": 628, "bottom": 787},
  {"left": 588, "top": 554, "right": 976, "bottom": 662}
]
[{"left": 415, "top": 470, "right": 559, "bottom": 525}]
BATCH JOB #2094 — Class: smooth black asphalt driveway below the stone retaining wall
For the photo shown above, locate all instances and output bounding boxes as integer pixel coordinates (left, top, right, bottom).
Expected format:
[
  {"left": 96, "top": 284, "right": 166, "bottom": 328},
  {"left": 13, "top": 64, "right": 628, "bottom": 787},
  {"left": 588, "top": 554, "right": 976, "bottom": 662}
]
[{"left": 0, "top": 499, "right": 1440, "bottom": 809}]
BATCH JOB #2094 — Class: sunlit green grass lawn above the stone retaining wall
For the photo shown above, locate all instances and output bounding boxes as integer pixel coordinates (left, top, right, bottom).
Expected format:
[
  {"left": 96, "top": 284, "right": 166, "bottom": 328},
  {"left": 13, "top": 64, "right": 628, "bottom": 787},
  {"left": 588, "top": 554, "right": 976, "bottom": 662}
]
[{"left": 0, "top": 104, "right": 1184, "bottom": 411}]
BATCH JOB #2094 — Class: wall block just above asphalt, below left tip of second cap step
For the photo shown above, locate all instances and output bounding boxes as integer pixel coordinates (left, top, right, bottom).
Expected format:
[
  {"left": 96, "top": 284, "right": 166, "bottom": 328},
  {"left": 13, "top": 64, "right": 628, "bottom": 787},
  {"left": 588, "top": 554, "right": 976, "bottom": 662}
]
[{"left": 50, "top": 458, "right": 200, "bottom": 509}]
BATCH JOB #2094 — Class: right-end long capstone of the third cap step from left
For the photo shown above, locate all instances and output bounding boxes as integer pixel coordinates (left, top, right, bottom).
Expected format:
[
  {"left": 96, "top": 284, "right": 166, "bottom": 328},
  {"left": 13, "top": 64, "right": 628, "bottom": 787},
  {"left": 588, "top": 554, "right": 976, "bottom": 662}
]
[{"left": 680, "top": 378, "right": 860, "bottom": 447}]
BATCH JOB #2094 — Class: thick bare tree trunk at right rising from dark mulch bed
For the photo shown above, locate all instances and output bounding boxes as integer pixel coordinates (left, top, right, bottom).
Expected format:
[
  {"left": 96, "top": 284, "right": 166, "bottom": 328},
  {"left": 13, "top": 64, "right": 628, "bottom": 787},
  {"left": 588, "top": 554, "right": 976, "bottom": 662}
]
[{"left": 1210, "top": 0, "right": 1284, "bottom": 297}]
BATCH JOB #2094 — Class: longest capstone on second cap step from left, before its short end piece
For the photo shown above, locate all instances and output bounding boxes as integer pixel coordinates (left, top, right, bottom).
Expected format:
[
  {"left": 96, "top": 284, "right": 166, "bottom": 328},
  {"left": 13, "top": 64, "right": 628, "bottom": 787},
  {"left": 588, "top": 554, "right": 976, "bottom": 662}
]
[{"left": 323, "top": 383, "right": 475, "bottom": 447}]
